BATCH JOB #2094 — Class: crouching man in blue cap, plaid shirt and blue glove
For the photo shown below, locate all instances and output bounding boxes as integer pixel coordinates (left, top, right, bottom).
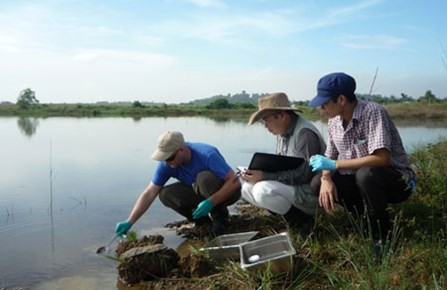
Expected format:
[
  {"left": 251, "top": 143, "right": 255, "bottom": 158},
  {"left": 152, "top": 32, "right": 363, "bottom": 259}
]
[{"left": 309, "top": 72, "right": 416, "bottom": 255}]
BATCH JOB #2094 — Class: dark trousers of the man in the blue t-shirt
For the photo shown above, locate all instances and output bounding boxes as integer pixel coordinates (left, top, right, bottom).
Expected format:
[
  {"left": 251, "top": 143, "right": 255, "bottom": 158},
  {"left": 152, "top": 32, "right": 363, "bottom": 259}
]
[{"left": 159, "top": 171, "right": 241, "bottom": 221}]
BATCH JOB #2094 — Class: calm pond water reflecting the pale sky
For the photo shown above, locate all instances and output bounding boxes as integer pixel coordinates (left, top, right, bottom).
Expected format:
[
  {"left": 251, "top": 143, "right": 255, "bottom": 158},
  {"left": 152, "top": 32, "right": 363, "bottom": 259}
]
[{"left": 0, "top": 117, "right": 447, "bottom": 289}]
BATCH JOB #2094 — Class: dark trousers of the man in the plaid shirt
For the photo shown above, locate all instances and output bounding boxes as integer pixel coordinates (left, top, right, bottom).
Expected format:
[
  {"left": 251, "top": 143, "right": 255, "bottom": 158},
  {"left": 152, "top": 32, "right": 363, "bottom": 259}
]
[{"left": 311, "top": 167, "right": 411, "bottom": 240}]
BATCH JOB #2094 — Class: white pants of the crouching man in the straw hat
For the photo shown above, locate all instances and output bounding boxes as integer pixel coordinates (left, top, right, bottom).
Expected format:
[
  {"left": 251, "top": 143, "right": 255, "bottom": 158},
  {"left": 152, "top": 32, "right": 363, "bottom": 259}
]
[{"left": 241, "top": 180, "right": 319, "bottom": 215}]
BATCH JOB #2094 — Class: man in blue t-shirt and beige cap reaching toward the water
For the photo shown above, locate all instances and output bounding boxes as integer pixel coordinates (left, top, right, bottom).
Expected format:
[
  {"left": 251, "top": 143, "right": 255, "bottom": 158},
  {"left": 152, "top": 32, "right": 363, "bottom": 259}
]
[{"left": 115, "top": 131, "right": 241, "bottom": 236}]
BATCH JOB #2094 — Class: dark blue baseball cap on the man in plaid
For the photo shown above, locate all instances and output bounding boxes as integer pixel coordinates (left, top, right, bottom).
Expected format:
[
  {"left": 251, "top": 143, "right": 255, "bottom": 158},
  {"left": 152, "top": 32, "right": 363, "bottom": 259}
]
[{"left": 309, "top": 72, "right": 356, "bottom": 108}]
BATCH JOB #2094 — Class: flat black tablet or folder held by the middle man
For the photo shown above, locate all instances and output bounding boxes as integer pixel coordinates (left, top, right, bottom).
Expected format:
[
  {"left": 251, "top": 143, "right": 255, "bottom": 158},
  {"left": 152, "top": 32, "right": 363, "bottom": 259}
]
[{"left": 248, "top": 152, "right": 304, "bottom": 172}]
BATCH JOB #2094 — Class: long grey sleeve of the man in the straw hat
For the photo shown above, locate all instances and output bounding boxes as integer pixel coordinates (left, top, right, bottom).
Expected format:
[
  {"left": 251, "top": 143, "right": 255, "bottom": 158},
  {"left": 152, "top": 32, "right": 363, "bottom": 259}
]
[{"left": 262, "top": 129, "right": 320, "bottom": 185}]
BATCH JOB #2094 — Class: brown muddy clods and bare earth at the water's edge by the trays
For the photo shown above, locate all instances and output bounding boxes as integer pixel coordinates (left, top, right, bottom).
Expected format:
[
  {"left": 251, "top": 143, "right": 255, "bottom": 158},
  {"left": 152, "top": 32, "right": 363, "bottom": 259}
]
[{"left": 116, "top": 203, "right": 286, "bottom": 290}]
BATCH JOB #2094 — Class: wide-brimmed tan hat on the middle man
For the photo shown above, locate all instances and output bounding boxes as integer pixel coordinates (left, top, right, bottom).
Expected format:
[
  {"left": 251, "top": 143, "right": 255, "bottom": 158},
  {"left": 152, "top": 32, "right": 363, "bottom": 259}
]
[{"left": 248, "top": 93, "right": 302, "bottom": 125}]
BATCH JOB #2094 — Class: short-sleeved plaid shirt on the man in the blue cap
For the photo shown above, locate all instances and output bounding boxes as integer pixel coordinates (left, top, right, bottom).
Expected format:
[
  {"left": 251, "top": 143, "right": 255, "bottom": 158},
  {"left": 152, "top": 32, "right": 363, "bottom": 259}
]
[{"left": 325, "top": 100, "right": 414, "bottom": 178}]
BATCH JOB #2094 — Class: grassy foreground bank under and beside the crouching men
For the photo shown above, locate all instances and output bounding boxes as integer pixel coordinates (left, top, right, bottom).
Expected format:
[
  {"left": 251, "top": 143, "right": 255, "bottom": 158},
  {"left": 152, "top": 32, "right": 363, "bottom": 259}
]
[{"left": 184, "top": 140, "right": 447, "bottom": 289}]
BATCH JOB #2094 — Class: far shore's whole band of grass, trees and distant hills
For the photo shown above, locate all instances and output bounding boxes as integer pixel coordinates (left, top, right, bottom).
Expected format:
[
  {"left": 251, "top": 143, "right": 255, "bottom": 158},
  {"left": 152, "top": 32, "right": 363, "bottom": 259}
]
[{"left": 0, "top": 88, "right": 447, "bottom": 120}]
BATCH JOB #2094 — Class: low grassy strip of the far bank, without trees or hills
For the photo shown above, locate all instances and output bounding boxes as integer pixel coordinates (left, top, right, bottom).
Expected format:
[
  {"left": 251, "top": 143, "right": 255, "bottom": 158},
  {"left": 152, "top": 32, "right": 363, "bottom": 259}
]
[{"left": 0, "top": 102, "right": 447, "bottom": 120}]
